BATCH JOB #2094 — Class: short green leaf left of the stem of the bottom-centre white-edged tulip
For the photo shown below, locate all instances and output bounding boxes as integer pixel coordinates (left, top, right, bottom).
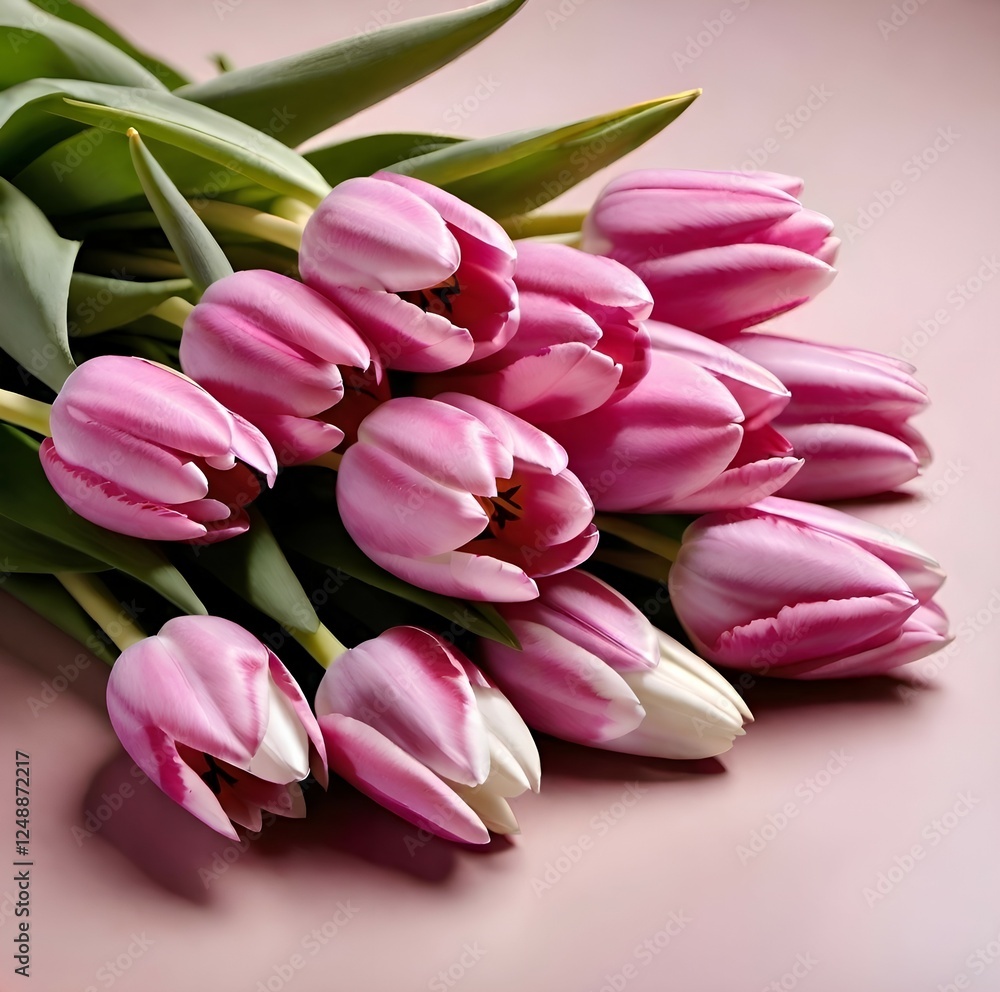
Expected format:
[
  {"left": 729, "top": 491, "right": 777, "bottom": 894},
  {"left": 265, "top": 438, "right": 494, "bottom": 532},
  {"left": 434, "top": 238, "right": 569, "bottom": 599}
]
[{"left": 198, "top": 510, "right": 319, "bottom": 633}]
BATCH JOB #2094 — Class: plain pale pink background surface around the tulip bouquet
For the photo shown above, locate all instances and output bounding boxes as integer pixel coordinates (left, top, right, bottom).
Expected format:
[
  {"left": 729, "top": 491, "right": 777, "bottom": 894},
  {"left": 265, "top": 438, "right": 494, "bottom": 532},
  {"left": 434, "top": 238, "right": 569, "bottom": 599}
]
[{"left": 0, "top": 0, "right": 1000, "bottom": 992}]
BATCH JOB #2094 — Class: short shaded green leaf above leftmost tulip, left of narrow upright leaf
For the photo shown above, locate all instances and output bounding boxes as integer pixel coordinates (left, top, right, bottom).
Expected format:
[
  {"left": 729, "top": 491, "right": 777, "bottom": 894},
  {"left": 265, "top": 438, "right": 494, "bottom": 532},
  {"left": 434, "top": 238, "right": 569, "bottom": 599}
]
[{"left": 67, "top": 272, "right": 191, "bottom": 338}]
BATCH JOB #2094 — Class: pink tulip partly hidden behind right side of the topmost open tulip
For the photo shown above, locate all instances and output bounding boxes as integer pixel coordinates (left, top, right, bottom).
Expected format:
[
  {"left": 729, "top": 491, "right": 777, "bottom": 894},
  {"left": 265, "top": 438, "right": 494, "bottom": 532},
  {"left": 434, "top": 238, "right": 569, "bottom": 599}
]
[{"left": 420, "top": 241, "right": 653, "bottom": 423}]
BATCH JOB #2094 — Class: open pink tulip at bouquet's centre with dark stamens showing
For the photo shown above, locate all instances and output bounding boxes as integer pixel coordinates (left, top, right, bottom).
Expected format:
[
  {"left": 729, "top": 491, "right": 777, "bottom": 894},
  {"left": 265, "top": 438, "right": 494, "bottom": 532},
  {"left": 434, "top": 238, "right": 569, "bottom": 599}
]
[{"left": 337, "top": 393, "right": 597, "bottom": 602}]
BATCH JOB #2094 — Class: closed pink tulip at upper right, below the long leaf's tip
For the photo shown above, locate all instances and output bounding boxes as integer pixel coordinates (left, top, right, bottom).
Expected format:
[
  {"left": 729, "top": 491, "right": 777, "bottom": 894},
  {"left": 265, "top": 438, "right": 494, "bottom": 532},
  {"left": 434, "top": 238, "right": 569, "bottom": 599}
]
[{"left": 583, "top": 169, "right": 839, "bottom": 337}]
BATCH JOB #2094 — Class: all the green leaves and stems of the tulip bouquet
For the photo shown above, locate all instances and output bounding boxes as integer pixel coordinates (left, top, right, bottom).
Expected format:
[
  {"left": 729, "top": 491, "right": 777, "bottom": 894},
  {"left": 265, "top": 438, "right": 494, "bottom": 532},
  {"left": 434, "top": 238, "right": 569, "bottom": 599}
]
[{"left": 0, "top": 0, "right": 697, "bottom": 661}]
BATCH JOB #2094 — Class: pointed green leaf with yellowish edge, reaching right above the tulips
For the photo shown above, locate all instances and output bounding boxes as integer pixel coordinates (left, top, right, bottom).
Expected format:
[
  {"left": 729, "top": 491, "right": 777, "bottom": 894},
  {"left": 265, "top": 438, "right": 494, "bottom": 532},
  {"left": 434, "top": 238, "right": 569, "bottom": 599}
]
[{"left": 389, "top": 90, "right": 700, "bottom": 219}]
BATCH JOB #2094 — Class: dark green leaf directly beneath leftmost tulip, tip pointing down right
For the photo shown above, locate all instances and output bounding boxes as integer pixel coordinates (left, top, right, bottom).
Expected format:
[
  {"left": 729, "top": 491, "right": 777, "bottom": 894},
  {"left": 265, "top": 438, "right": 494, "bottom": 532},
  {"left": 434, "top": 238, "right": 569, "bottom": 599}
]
[{"left": 0, "top": 424, "right": 207, "bottom": 613}]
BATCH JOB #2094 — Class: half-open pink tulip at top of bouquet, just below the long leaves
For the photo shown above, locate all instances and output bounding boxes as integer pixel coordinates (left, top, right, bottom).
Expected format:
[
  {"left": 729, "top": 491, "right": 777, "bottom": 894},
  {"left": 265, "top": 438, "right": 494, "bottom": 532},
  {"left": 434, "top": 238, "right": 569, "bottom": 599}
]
[{"left": 299, "top": 172, "right": 517, "bottom": 372}]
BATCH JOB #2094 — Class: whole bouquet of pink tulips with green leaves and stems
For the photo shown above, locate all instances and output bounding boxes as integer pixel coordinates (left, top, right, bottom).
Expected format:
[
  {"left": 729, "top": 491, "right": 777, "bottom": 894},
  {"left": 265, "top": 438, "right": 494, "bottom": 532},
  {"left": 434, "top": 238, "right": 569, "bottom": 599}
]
[{"left": 0, "top": 0, "right": 948, "bottom": 843}]
